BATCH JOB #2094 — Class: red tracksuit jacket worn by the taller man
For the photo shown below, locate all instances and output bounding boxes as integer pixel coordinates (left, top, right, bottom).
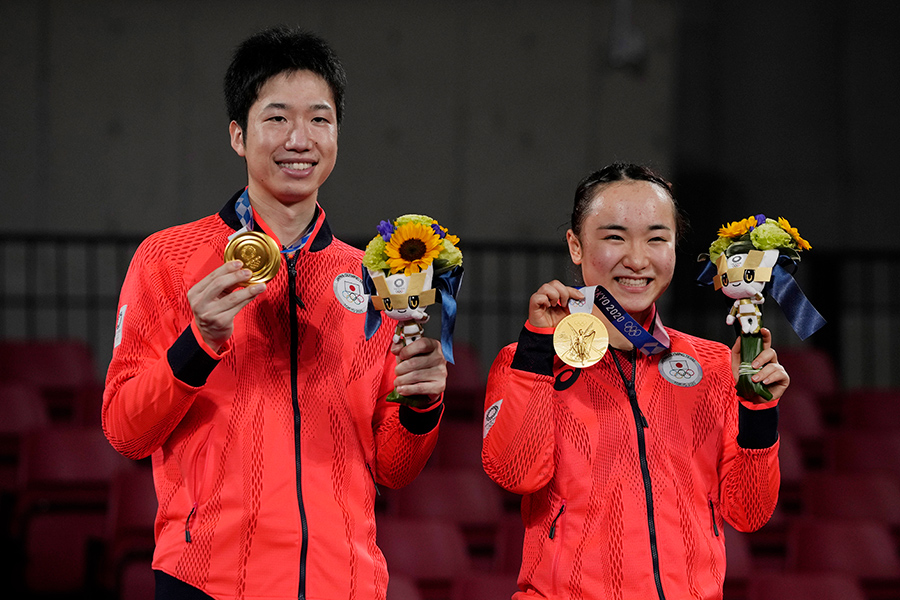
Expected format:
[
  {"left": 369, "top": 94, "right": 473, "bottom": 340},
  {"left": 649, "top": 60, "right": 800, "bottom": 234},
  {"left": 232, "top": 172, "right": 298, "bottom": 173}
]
[{"left": 103, "top": 195, "right": 441, "bottom": 600}]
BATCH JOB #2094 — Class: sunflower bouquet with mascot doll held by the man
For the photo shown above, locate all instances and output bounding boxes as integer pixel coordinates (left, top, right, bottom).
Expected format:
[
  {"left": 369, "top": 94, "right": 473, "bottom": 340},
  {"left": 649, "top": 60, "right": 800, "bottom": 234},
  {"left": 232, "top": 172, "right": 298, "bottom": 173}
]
[{"left": 363, "top": 214, "right": 463, "bottom": 405}]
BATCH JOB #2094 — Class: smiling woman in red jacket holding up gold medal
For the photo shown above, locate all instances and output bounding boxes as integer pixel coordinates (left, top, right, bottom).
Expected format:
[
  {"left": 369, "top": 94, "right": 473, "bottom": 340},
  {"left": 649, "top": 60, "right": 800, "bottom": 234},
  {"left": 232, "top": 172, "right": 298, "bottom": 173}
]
[{"left": 482, "top": 164, "right": 789, "bottom": 600}]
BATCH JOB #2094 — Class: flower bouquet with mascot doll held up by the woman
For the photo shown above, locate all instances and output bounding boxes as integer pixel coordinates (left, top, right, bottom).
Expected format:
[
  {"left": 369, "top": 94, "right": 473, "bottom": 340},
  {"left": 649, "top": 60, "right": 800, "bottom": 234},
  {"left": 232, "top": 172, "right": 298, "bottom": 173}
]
[{"left": 700, "top": 214, "right": 825, "bottom": 400}]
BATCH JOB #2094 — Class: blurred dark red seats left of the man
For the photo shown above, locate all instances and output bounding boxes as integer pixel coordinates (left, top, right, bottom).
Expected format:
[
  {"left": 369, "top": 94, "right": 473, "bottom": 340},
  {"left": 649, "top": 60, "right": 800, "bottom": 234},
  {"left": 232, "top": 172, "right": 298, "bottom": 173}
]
[{"left": 0, "top": 340, "right": 156, "bottom": 600}]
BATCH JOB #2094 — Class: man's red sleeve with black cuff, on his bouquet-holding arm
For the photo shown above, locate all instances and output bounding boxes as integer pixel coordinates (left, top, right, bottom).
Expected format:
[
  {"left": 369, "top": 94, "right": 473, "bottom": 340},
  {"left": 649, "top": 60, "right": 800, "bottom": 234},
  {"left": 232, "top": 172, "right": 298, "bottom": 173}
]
[{"left": 373, "top": 352, "right": 444, "bottom": 489}]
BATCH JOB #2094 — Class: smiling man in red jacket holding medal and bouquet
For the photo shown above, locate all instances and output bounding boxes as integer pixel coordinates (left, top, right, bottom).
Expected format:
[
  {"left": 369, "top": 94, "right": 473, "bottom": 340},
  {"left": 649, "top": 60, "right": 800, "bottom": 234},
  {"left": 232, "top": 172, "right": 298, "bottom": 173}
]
[{"left": 103, "top": 28, "right": 446, "bottom": 600}]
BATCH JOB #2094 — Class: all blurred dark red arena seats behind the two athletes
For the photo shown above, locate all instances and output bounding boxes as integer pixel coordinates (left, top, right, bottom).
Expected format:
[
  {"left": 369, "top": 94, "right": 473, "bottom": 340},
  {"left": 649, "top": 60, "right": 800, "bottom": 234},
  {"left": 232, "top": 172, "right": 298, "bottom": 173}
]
[{"left": 0, "top": 340, "right": 900, "bottom": 600}]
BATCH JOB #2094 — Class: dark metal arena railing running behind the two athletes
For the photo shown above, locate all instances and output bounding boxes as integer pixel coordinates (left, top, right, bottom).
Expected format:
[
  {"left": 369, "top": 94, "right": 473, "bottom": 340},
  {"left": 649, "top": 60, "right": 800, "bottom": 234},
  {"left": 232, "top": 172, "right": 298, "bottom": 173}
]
[{"left": 0, "top": 233, "right": 888, "bottom": 387}]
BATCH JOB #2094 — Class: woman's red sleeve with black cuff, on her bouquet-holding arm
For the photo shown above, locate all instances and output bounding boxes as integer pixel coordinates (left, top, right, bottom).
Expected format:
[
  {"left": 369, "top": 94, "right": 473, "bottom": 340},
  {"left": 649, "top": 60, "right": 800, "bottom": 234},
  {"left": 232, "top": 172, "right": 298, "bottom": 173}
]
[{"left": 719, "top": 352, "right": 781, "bottom": 532}]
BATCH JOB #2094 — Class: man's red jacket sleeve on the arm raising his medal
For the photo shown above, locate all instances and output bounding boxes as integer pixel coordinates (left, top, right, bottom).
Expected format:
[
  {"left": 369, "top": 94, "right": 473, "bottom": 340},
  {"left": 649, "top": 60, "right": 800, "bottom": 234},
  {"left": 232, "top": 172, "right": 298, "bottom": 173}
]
[{"left": 101, "top": 237, "right": 221, "bottom": 459}]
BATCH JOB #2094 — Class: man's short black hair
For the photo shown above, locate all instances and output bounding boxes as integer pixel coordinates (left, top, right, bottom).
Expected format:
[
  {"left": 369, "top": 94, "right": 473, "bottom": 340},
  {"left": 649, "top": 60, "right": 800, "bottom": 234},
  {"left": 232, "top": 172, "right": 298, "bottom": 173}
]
[{"left": 223, "top": 27, "right": 347, "bottom": 131}]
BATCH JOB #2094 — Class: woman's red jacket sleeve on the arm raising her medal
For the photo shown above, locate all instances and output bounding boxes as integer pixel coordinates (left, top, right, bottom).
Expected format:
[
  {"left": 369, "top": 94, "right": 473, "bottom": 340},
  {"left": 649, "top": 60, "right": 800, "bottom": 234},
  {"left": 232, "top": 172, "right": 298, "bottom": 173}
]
[{"left": 481, "top": 324, "right": 555, "bottom": 494}]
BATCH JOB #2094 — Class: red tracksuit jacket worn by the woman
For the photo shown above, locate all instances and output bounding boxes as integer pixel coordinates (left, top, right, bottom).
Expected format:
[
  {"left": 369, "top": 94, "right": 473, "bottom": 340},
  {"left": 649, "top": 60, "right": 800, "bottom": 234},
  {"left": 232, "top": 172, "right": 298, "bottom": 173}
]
[{"left": 482, "top": 326, "right": 780, "bottom": 600}]
